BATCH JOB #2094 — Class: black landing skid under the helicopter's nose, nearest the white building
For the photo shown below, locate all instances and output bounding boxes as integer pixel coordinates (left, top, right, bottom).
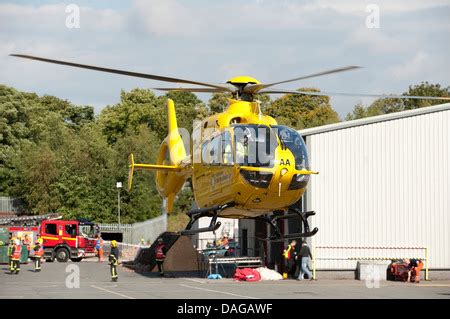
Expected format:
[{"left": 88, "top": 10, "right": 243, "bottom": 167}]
[{"left": 256, "top": 207, "right": 319, "bottom": 242}]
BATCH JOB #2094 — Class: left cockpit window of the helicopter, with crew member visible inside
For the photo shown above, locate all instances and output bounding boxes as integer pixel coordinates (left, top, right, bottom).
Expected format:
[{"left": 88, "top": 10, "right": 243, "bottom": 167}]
[{"left": 233, "top": 124, "right": 278, "bottom": 167}]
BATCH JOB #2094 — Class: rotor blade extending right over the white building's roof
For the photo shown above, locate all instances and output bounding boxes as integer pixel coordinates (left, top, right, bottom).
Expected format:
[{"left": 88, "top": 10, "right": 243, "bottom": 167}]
[{"left": 258, "top": 90, "right": 450, "bottom": 100}]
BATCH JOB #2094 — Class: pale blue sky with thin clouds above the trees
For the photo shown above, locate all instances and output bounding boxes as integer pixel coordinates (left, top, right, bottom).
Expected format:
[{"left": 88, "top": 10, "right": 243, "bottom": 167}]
[{"left": 0, "top": 0, "right": 450, "bottom": 117}]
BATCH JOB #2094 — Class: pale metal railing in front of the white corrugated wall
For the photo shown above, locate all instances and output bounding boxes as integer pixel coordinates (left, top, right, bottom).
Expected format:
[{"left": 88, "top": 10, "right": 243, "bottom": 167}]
[{"left": 311, "top": 246, "right": 429, "bottom": 280}]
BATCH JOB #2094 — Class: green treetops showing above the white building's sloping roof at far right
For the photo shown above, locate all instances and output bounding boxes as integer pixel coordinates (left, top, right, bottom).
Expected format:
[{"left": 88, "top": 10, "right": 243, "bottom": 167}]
[{"left": 345, "top": 82, "right": 450, "bottom": 120}]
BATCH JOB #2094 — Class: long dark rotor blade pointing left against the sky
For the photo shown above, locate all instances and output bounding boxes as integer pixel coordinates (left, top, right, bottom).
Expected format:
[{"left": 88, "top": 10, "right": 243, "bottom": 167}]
[{"left": 10, "top": 54, "right": 227, "bottom": 89}]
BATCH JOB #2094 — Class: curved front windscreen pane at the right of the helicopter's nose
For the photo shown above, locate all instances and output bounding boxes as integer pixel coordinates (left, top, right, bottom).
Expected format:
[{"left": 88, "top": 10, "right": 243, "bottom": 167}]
[{"left": 273, "top": 125, "right": 309, "bottom": 170}]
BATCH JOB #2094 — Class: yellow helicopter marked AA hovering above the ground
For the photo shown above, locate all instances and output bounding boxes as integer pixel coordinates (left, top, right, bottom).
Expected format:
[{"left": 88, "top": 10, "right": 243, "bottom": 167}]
[{"left": 12, "top": 54, "right": 450, "bottom": 241}]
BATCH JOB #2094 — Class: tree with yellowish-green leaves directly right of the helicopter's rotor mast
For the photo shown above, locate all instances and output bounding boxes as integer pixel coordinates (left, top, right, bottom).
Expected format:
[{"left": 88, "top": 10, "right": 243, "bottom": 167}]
[{"left": 265, "top": 88, "right": 340, "bottom": 129}]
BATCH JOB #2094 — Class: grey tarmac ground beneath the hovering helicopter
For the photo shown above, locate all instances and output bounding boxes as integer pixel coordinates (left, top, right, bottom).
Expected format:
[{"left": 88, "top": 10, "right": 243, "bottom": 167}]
[{"left": 0, "top": 260, "right": 450, "bottom": 300}]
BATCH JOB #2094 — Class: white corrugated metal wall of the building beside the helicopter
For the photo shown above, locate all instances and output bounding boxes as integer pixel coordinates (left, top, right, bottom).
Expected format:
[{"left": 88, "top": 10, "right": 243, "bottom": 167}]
[{"left": 306, "top": 110, "right": 450, "bottom": 269}]
